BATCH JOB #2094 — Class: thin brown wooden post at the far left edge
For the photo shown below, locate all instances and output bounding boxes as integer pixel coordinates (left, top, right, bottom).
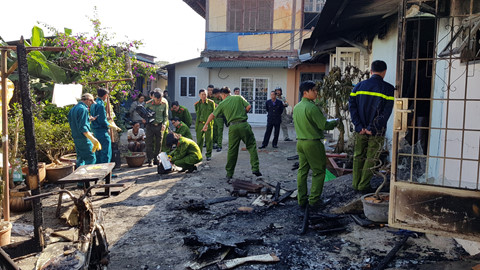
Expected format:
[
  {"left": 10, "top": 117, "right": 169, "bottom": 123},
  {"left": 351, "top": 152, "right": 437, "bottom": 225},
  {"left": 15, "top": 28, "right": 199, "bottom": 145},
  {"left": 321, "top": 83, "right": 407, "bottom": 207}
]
[{"left": 0, "top": 51, "right": 10, "bottom": 221}]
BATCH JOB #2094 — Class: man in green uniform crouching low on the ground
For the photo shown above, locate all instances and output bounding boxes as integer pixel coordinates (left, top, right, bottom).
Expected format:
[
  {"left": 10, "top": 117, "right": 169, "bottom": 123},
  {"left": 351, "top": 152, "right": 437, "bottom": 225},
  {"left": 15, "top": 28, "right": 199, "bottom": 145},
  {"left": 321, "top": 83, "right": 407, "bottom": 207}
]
[{"left": 166, "top": 133, "right": 202, "bottom": 172}]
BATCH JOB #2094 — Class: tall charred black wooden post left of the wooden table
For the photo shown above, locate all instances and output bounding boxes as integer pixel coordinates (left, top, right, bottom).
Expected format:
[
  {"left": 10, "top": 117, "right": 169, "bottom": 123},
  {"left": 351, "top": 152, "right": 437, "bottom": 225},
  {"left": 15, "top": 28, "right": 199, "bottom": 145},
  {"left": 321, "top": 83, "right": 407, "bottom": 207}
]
[{"left": 17, "top": 37, "right": 45, "bottom": 248}]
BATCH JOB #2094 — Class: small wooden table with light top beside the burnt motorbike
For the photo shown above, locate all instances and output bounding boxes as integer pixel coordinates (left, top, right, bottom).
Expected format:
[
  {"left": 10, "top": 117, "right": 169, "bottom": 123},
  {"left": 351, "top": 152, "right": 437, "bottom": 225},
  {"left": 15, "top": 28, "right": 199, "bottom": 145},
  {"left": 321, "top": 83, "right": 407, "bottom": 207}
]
[{"left": 55, "top": 162, "right": 115, "bottom": 217}]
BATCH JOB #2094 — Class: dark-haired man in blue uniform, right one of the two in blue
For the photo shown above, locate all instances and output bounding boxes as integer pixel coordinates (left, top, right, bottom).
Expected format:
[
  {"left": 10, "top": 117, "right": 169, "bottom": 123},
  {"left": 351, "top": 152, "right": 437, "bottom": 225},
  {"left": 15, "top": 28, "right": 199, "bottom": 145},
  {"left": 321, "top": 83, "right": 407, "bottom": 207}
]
[{"left": 90, "top": 88, "right": 112, "bottom": 164}]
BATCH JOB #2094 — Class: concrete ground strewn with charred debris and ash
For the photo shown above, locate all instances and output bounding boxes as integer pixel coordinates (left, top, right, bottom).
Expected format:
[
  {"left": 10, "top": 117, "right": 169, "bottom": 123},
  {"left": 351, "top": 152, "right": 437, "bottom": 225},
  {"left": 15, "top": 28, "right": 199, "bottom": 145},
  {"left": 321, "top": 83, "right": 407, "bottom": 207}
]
[{"left": 8, "top": 123, "right": 480, "bottom": 270}]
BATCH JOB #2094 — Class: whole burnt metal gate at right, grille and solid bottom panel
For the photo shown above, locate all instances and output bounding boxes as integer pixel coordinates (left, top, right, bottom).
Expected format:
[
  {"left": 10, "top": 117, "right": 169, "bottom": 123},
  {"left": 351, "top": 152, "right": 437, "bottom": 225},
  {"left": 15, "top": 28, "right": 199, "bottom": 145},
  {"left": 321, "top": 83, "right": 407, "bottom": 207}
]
[{"left": 389, "top": 0, "right": 480, "bottom": 241}]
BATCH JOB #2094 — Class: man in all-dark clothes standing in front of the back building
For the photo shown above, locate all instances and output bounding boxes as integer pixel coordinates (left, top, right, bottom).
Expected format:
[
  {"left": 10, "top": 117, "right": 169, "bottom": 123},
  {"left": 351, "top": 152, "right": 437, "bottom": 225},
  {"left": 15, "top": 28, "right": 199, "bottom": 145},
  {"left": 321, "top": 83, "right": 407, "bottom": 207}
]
[{"left": 259, "top": 91, "right": 284, "bottom": 149}]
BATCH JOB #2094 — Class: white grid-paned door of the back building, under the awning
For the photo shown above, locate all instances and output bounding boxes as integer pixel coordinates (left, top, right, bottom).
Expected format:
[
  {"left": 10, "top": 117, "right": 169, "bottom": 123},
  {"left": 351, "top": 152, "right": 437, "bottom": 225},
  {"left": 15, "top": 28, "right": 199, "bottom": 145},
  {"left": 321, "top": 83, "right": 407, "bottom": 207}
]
[{"left": 240, "top": 77, "right": 269, "bottom": 123}]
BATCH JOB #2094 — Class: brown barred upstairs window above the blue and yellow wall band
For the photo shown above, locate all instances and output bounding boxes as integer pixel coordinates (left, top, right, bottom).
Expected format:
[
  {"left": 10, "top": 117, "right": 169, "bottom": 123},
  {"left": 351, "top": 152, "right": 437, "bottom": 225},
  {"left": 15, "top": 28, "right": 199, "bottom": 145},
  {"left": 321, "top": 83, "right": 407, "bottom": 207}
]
[{"left": 227, "top": 0, "right": 273, "bottom": 32}]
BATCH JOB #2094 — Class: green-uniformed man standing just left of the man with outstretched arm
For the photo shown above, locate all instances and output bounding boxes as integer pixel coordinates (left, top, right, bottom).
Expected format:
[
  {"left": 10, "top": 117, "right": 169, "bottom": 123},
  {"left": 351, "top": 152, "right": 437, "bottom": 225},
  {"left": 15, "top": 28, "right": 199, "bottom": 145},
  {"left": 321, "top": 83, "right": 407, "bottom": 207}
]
[{"left": 195, "top": 89, "right": 215, "bottom": 160}]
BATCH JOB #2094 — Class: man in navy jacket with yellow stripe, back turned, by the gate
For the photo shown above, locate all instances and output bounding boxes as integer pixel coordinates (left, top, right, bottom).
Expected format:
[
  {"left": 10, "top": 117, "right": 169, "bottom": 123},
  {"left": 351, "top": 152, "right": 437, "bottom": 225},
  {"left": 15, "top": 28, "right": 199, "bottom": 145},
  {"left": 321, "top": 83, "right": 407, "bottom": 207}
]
[{"left": 348, "top": 60, "right": 395, "bottom": 193}]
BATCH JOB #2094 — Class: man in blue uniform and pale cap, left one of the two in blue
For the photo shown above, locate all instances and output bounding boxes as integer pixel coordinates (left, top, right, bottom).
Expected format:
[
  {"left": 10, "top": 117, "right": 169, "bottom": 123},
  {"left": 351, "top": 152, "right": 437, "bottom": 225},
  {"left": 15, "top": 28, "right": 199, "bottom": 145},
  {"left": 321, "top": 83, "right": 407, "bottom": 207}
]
[{"left": 68, "top": 93, "right": 102, "bottom": 168}]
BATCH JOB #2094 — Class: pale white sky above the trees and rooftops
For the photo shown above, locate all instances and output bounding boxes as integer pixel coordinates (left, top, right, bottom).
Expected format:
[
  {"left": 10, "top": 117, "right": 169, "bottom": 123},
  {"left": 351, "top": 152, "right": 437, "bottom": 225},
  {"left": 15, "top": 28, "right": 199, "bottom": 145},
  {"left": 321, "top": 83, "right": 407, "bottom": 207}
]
[{"left": 0, "top": 0, "right": 205, "bottom": 63}]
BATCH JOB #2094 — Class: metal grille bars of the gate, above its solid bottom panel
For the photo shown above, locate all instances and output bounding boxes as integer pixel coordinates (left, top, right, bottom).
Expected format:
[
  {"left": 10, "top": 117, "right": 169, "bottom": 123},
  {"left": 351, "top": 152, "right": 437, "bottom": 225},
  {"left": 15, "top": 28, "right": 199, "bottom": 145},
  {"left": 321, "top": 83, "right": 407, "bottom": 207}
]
[{"left": 396, "top": 0, "right": 480, "bottom": 190}]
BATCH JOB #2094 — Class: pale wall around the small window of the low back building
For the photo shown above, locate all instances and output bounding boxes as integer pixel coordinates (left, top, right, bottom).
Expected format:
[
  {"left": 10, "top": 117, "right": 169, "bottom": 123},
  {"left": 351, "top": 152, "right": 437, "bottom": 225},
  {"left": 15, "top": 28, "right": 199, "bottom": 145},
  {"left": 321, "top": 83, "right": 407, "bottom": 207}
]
[{"left": 173, "top": 58, "right": 209, "bottom": 113}]
